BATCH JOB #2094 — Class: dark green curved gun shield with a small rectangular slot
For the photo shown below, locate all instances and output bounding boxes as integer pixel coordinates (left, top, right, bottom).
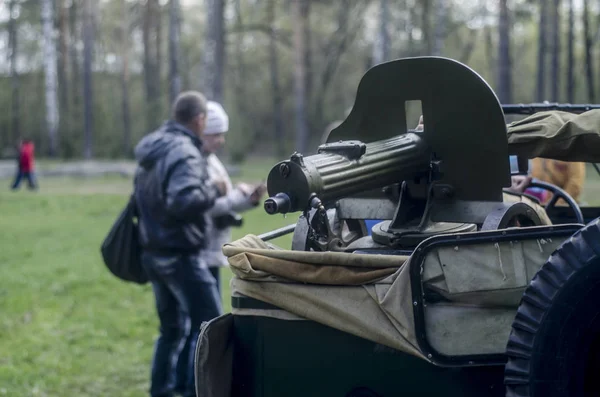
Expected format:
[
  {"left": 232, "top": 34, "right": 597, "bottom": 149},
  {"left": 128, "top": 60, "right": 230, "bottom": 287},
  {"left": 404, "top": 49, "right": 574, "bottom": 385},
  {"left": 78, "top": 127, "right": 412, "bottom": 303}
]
[{"left": 327, "top": 57, "right": 510, "bottom": 202}]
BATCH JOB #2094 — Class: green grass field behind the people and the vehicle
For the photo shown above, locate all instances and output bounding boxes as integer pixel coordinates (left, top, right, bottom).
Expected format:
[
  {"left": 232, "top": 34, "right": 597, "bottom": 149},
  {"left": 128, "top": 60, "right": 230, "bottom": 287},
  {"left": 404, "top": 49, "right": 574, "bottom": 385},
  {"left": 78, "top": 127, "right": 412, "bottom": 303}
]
[{"left": 0, "top": 161, "right": 600, "bottom": 397}]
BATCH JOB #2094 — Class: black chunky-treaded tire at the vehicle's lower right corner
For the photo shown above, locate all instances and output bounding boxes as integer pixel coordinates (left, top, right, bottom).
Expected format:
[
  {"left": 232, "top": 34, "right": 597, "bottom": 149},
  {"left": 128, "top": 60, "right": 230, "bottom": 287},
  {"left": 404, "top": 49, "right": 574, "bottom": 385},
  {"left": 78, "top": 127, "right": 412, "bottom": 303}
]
[{"left": 505, "top": 218, "right": 600, "bottom": 397}]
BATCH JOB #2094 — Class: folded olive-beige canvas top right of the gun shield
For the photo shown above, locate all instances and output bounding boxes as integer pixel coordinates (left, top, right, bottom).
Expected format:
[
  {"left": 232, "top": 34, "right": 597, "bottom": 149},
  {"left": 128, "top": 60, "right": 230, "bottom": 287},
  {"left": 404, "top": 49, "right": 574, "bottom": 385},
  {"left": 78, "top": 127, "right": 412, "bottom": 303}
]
[{"left": 508, "top": 110, "right": 600, "bottom": 162}]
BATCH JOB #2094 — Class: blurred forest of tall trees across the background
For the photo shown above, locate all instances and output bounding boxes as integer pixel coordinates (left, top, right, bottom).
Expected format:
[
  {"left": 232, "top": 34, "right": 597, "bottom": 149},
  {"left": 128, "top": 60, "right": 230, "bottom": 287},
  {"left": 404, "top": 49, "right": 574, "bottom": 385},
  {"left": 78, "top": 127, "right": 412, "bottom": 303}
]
[{"left": 0, "top": 0, "right": 600, "bottom": 163}]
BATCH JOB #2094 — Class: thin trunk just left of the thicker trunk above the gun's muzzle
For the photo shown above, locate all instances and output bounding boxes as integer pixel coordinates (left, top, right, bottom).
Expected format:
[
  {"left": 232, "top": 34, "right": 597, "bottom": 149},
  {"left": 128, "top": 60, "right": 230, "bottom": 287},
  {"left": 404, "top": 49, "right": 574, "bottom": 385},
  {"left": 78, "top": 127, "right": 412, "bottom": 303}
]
[{"left": 267, "top": 0, "right": 285, "bottom": 157}]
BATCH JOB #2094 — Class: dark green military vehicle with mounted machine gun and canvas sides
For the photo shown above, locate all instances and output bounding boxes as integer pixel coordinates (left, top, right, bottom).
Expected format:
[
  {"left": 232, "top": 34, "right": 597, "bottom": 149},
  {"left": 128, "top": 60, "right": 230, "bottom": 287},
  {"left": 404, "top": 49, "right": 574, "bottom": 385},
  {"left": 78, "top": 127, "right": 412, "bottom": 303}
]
[{"left": 195, "top": 57, "right": 600, "bottom": 397}]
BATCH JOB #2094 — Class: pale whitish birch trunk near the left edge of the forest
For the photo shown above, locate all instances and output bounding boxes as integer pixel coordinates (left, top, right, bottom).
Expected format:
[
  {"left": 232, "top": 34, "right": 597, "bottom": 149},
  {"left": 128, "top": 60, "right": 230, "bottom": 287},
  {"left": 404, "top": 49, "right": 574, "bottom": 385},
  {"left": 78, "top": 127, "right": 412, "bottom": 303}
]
[{"left": 41, "top": 0, "right": 59, "bottom": 157}]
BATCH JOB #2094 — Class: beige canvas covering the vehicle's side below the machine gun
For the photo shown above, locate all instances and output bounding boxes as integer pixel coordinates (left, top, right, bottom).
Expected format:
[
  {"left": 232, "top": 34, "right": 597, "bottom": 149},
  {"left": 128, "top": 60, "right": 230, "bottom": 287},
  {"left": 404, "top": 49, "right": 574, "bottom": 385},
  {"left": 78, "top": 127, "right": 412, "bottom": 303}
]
[{"left": 224, "top": 227, "right": 562, "bottom": 360}]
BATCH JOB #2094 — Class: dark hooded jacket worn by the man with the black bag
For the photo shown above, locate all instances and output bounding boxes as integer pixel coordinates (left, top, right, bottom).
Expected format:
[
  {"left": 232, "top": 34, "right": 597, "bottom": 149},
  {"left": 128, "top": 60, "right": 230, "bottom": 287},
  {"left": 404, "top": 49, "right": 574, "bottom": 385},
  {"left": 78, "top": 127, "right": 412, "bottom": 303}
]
[{"left": 135, "top": 121, "right": 218, "bottom": 254}]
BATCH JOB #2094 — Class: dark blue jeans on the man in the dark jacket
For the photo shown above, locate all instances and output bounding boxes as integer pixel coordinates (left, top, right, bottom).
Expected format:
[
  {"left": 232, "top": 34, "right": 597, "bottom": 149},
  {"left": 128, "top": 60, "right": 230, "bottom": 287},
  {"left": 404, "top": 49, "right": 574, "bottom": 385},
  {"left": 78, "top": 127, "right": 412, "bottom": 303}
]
[{"left": 142, "top": 252, "right": 223, "bottom": 397}]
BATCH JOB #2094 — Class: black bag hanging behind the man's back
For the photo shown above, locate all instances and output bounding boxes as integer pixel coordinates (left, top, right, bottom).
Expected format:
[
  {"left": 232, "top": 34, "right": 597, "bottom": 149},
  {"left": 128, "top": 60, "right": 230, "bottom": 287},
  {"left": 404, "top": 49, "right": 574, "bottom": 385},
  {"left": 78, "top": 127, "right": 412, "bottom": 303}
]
[{"left": 101, "top": 194, "right": 148, "bottom": 284}]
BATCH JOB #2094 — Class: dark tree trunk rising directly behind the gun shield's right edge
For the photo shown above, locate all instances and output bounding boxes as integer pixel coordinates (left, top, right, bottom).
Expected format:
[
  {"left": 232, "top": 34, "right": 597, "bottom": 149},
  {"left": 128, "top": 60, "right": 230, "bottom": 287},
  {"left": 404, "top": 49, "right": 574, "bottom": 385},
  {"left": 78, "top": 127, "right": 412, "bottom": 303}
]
[{"left": 498, "top": 0, "right": 512, "bottom": 103}]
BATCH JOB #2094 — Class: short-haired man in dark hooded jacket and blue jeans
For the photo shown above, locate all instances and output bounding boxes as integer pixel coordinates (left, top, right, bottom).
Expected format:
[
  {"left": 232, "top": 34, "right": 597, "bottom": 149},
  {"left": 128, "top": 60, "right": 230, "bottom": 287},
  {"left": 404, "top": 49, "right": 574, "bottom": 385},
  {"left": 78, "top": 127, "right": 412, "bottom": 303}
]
[{"left": 135, "top": 92, "right": 222, "bottom": 397}]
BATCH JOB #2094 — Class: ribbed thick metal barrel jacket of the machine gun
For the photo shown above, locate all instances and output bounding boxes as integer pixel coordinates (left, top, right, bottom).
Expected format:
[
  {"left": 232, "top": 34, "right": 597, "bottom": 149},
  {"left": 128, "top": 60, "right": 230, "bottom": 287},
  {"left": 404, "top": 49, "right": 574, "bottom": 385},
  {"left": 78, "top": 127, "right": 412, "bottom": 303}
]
[{"left": 265, "top": 132, "right": 431, "bottom": 214}]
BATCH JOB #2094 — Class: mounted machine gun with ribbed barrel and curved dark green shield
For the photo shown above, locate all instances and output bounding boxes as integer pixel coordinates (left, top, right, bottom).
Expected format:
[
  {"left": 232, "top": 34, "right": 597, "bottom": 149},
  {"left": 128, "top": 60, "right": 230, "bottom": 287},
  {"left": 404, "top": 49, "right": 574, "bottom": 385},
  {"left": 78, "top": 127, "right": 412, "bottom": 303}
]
[{"left": 264, "top": 57, "right": 540, "bottom": 251}]
